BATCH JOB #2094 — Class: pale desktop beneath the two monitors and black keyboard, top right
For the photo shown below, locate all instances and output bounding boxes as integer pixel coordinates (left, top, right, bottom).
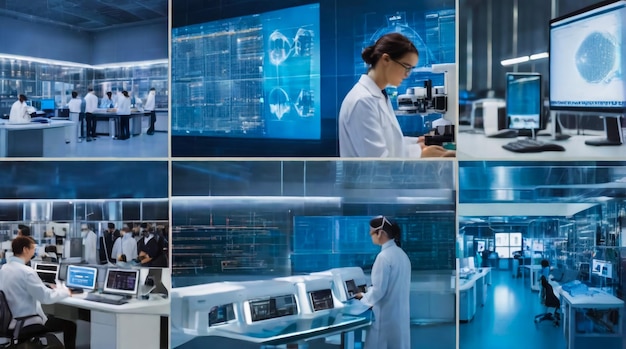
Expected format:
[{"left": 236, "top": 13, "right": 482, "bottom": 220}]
[{"left": 457, "top": 130, "right": 626, "bottom": 160}]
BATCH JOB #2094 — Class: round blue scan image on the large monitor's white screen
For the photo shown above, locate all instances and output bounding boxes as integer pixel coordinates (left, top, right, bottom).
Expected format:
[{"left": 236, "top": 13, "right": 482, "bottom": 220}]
[{"left": 576, "top": 32, "right": 617, "bottom": 83}]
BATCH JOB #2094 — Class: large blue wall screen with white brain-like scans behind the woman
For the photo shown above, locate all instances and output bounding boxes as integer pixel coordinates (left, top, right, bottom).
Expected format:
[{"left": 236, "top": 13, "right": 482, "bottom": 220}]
[{"left": 172, "top": 4, "right": 321, "bottom": 140}]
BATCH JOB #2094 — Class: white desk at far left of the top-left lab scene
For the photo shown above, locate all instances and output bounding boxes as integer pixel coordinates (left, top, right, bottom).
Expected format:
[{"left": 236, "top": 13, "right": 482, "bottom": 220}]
[{"left": 0, "top": 120, "right": 76, "bottom": 157}]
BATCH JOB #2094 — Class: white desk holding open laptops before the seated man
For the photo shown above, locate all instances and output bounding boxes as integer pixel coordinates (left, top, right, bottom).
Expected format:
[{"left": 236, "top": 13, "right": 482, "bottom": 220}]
[{"left": 46, "top": 293, "right": 170, "bottom": 349}]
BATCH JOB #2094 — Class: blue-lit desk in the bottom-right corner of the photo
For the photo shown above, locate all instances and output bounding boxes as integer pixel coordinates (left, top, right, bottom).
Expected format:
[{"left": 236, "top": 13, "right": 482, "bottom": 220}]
[{"left": 559, "top": 288, "right": 624, "bottom": 349}]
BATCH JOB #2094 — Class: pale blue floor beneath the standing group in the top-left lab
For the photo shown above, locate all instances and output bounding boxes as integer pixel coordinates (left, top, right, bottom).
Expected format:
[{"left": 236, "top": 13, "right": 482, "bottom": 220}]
[{"left": 56, "top": 132, "right": 169, "bottom": 158}]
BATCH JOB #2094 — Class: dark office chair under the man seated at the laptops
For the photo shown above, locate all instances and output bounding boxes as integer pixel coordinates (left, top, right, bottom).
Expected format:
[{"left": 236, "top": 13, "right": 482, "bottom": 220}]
[{"left": 0, "top": 291, "right": 65, "bottom": 349}]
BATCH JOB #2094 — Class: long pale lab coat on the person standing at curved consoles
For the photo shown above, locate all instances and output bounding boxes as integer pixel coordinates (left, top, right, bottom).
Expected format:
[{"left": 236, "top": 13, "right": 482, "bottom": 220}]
[{"left": 361, "top": 240, "right": 411, "bottom": 349}]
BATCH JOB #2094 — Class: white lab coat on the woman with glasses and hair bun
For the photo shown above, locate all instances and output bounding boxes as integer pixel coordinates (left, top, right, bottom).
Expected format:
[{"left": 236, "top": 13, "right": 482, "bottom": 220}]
[{"left": 339, "top": 74, "right": 421, "bottom": 158}]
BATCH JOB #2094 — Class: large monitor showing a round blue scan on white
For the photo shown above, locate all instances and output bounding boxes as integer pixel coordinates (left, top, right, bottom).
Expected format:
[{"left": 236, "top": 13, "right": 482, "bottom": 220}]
[{"left": 550, "top": 0, "right": 626, "bottom": 113}]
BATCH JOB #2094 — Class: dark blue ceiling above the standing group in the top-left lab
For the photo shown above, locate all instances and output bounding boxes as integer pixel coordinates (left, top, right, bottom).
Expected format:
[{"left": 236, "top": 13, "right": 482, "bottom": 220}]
[{"left": 0, "top": 0, "right": 168, "bottom": 31}]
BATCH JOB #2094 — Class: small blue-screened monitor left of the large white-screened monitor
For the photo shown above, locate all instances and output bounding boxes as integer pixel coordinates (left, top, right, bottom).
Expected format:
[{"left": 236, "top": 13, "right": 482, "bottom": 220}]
[{"left": 506, "top": 73, "right": 545, "bottom": 135}]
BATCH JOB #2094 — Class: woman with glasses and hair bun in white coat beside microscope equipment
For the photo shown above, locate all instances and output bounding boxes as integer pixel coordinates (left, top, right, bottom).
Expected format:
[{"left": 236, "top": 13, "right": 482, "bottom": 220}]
[{"left": 339, "top": 33, "right": 421, "bottom": 158}]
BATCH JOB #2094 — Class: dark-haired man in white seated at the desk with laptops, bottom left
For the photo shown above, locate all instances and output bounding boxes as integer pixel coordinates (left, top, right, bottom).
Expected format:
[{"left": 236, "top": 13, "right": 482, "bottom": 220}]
[{"left": 0, "top": 236, "right": 76, "bottom": 349}]
